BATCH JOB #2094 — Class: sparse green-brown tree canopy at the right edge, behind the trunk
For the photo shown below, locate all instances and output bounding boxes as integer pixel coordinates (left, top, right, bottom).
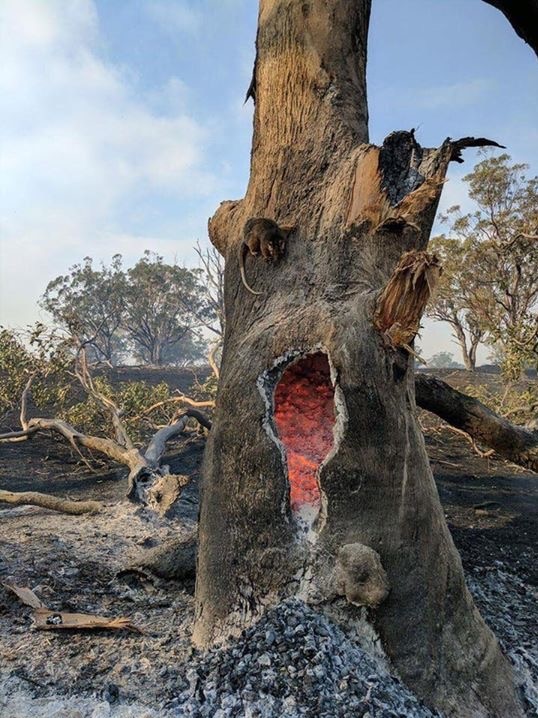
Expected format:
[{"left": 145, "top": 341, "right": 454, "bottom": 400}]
[{"left": 429, "top": 154, "right": 538, "bottom": 380}]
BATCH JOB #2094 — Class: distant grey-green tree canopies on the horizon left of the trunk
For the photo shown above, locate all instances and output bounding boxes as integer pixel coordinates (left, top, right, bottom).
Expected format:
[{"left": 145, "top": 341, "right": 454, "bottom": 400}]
[{"left": 41, "top": 251, "right": 216, "bottom": 365}]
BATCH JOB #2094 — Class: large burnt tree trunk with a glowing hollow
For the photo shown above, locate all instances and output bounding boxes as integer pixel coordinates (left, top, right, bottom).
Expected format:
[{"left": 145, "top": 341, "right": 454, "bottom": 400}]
[{"left": 194, "top": 0, "right": 521, "bottom": 716}]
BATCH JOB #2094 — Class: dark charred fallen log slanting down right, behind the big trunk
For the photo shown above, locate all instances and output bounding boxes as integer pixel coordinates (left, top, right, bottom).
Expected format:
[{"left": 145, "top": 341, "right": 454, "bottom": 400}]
[{"left": 415, "top": 374, "right": 538, "bottom": 472}]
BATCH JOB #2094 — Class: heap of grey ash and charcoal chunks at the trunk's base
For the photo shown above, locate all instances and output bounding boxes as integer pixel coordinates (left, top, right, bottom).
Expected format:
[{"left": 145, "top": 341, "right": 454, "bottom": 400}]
[{"left": 165, "top": 599, "right": 437, "bottom": 718}]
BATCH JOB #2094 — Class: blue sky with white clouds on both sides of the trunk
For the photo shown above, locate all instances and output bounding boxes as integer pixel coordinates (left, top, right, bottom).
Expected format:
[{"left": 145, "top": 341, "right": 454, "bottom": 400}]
[{"left": 0, "top": 0, "right": 538, "bottom": 356}]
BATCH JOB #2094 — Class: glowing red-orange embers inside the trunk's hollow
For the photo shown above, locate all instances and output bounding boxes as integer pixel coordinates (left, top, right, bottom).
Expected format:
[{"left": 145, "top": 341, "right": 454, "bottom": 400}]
[{"left": 275, "top": 353, "right": 334, "bottom": 511}]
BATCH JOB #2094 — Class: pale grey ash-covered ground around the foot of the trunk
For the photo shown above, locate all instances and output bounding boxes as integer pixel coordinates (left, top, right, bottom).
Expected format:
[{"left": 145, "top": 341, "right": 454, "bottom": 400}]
[{"left": 0, "top": 464, "right": 538, "bottom": 718}]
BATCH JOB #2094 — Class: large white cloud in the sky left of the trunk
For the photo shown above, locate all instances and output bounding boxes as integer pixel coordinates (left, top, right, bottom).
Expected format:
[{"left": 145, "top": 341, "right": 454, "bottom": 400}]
[{"left": 0, "top": 0, "right": 215, "bottom": 323}]
